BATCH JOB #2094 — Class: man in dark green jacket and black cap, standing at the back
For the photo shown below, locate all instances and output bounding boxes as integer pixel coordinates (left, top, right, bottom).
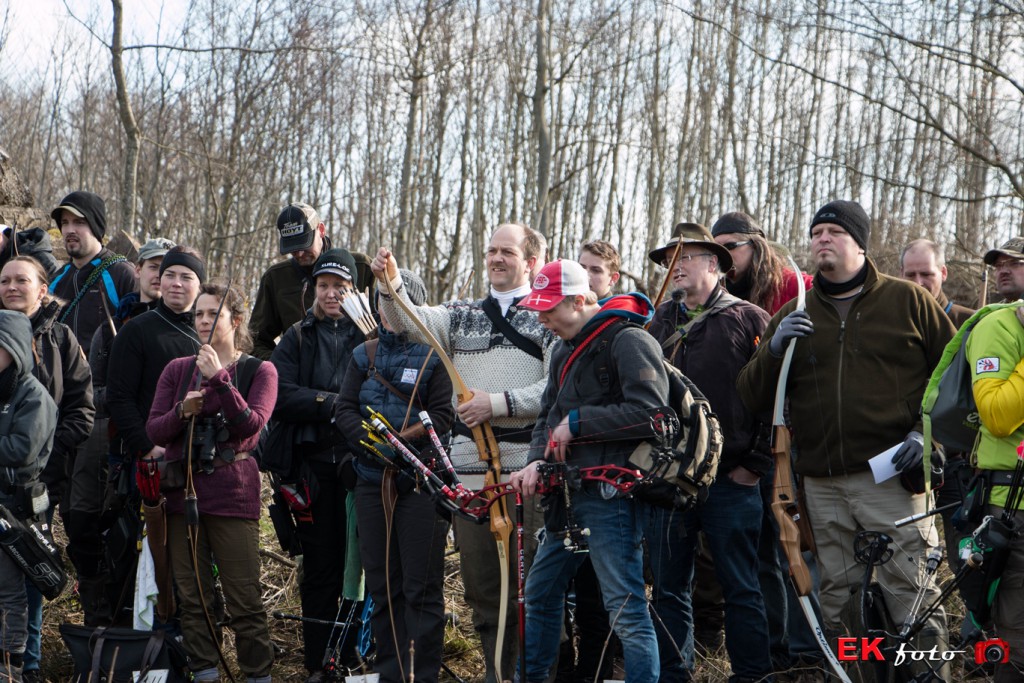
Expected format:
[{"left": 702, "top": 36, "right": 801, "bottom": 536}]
[{"left": 249, "top": 202, "right": 373, "bottom": 360}]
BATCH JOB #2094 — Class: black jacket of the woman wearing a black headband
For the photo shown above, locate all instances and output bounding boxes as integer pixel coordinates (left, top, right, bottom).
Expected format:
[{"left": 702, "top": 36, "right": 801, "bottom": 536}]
[{"left": 106, "top": 301, "right": 201, "bottom": 457}]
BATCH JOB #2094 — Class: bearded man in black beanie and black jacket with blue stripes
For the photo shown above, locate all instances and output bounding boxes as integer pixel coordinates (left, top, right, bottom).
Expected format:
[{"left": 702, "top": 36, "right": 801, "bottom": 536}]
[{"left": 50, "top": 189, "right": 135, "bottom": 357}]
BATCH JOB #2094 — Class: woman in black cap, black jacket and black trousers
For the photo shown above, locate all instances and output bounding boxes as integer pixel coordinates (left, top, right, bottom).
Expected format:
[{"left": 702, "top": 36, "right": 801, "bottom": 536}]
[{"left": 270, "top": 249, "right": 366, "bottom": 683}]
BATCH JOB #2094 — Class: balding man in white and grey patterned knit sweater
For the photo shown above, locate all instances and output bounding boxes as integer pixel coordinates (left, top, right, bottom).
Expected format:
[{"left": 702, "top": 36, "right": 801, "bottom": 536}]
[{"left": 372, "top": 223, "right": 553, "bottom": 683}]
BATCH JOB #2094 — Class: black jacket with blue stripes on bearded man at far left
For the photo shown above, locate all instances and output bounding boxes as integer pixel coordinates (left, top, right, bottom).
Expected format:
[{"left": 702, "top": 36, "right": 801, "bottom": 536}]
[{"left": 50, "top": 249, "right": 135, "bottom": 357}]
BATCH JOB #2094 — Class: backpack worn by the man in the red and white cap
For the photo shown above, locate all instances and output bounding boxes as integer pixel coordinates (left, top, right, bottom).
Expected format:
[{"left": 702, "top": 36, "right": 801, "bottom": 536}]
[{"left": 581, "top": 322, "right": 724, "bottom": 510}]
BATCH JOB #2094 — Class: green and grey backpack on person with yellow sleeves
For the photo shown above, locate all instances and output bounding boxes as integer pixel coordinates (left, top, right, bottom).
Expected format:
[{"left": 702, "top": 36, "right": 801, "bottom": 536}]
[{"left": 921, "top": 301, "right": 1024, "bottom": 454}]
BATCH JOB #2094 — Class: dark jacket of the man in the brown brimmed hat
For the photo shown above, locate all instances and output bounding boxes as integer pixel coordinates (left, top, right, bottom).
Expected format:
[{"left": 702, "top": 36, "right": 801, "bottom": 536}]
[{"left": 650, "top": 289, "right": 772, "bottom": 475}]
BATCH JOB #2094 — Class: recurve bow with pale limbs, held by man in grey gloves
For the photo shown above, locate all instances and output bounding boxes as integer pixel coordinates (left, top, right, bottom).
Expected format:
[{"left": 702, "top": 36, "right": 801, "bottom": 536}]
[{"left": 771, "top": 256, "right": 850, "bottom": 683}]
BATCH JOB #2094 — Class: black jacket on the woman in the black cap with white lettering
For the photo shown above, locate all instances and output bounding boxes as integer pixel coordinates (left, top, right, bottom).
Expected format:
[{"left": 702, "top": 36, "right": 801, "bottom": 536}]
[{"left": 270, "top": 312, "right": 366, "bottom": 453}]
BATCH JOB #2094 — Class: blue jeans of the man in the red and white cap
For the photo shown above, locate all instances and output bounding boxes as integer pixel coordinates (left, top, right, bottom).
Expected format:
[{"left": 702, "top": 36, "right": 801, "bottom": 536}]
[{"left": 526, "top": 486, "right": 658, "bottom": 683}]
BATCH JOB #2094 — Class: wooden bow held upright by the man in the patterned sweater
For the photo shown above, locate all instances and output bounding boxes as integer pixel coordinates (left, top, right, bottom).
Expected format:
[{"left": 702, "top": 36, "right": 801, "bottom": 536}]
[{"left": 384, "top": 272, "right": 512, "bottom": 681}]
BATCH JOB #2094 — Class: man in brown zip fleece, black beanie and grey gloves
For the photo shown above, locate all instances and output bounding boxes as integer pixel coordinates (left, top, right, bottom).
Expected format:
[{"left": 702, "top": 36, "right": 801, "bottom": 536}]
[{"left": 736, "top": 201, "right": 953, "bottom": 680}]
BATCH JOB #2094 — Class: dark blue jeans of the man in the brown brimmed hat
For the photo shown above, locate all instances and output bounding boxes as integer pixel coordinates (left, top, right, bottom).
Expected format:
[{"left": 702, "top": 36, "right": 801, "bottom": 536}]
[{"left": 647, "top": 474, "right": 772, "bottom": 683}]
